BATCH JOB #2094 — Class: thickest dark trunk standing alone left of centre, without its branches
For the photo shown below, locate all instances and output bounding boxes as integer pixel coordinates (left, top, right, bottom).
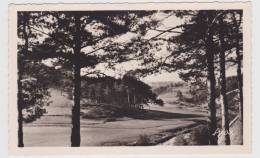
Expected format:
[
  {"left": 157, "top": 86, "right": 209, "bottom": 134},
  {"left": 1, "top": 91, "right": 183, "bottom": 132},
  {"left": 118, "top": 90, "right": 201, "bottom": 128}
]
[{"left": 71, "top": 14, "right": 81, "bottom": 147}]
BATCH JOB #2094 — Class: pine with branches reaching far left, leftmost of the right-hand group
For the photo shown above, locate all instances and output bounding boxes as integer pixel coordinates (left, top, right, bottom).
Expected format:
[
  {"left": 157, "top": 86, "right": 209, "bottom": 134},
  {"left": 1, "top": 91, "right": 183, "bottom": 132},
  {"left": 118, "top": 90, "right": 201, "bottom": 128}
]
[{"left": 138, "top": 10, "right": 218, "bottom": 145}]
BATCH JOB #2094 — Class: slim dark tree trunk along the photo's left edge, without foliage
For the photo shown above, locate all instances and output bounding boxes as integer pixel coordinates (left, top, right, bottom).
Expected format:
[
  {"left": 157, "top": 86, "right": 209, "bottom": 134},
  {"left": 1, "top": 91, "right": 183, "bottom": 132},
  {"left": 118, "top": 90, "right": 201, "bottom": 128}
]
[{"left": 17, "top": 13, "right": 29, "bottom": 147}]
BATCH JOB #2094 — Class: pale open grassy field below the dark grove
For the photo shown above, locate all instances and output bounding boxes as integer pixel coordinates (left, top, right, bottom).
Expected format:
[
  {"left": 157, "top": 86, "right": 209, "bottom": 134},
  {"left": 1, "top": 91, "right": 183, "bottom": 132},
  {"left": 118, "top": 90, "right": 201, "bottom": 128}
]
[{"left": 24, "top": 89, "right": 207, "bottom": 146}]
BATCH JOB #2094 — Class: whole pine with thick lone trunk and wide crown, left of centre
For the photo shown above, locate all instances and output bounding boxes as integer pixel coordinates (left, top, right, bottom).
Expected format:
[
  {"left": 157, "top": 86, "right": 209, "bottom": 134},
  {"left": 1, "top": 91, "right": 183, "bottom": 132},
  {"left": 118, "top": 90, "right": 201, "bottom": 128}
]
[{"left": 25, "top": 11, "right": 157, "bottom": 146}]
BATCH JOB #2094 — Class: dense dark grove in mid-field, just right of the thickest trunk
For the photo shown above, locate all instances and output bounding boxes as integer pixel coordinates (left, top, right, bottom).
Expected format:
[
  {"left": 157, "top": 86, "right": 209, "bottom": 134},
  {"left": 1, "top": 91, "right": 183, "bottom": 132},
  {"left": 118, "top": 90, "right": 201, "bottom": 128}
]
[{"left": 82, "top": 75, "right": 163, "bottom": 110}]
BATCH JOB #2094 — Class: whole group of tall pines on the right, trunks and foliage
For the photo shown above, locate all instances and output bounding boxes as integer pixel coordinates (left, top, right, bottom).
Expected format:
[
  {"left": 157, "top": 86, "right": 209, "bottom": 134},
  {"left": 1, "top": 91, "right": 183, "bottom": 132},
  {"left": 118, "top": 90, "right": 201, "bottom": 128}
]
[{"left": 138, "top": 10, "right": 243, "bottom": 144}]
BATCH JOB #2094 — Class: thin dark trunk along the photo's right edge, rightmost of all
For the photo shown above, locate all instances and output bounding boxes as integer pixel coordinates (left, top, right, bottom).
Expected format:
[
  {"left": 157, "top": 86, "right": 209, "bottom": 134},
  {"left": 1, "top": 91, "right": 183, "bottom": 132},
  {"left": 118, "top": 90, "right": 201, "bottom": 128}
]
[{"left": 233, "top": 12, "right": 243, "bottom": 144}]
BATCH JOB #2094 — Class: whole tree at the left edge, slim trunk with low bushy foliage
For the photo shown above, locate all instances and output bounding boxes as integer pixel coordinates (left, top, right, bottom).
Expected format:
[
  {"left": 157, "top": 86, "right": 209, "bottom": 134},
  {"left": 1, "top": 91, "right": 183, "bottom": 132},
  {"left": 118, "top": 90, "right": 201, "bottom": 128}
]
[{"left": 17, "top": 12, "right": 50, "bottom": 147}]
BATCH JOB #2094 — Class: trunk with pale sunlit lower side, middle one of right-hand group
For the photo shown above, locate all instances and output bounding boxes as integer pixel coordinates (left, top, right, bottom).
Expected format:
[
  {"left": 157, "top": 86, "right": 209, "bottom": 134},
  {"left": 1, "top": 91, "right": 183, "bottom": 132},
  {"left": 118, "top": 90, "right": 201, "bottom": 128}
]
[{"left": 219, "top": 16, "right": 230, "bottom": 145}]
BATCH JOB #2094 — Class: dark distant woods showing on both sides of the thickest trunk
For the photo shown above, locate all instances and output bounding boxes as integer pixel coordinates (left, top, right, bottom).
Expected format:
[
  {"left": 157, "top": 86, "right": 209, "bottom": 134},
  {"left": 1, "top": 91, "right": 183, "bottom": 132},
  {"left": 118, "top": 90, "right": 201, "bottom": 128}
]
[{"left": 44, "top": 67, "right": 164, "bottom": 111}]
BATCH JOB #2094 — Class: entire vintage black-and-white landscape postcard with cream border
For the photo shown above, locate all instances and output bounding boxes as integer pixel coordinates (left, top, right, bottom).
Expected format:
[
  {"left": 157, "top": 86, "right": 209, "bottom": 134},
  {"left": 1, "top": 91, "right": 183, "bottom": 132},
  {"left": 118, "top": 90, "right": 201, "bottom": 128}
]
[{"left": 9, "top": 2, "right": 251, "bottom": 155}]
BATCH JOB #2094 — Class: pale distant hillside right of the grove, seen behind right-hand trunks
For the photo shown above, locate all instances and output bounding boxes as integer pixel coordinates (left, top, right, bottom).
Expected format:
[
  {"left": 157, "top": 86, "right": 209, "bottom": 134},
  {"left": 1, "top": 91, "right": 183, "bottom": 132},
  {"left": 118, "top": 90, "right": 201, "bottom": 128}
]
[{"left": 150, "top": 80, "right": 239, "bottom": 122}]
